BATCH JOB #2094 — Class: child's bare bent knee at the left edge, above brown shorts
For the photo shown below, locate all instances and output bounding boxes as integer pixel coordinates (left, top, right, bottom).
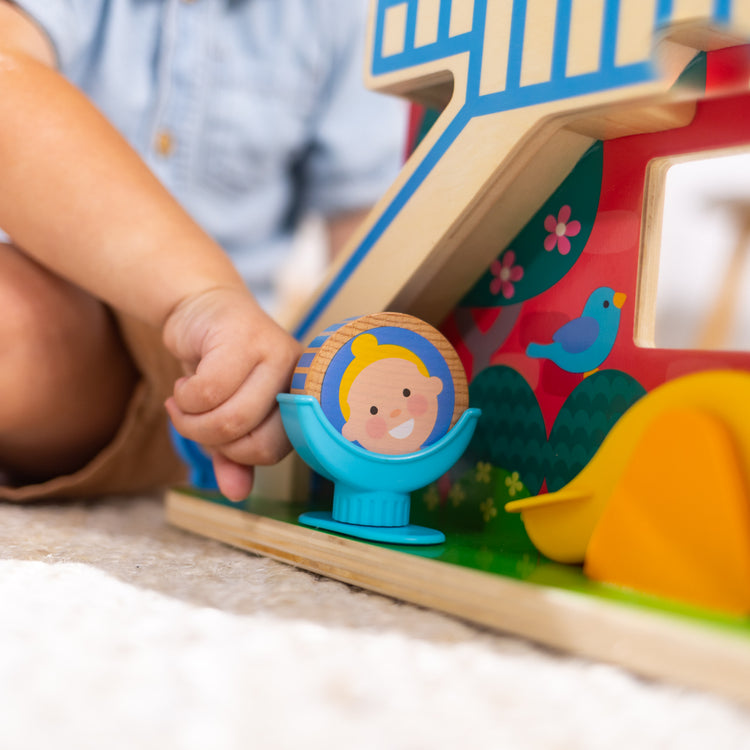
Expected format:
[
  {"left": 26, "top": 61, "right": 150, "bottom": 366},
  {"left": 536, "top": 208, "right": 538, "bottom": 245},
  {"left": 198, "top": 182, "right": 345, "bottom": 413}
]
[{"left": 0, "top": 244, "right": 137, "bottom": 483}]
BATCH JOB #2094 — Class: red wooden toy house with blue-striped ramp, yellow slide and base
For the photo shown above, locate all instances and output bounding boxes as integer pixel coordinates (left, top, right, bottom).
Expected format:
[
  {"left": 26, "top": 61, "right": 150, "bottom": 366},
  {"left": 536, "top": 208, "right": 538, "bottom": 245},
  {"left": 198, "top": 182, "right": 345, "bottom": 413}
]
[{"left": 167, "top": 0, "right": 750, "bottom": 703}]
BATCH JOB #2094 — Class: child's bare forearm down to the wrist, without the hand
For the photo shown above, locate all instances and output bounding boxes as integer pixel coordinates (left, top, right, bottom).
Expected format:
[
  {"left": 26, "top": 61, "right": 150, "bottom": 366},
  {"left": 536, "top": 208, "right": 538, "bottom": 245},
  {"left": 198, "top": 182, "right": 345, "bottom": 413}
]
[{"left": 0, "top": 2, "right": 242, "bottom": 326}]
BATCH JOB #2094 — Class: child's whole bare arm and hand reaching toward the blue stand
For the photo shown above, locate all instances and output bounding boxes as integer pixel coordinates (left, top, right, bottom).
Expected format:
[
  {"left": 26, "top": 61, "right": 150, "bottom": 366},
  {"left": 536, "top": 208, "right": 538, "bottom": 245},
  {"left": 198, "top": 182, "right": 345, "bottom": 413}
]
[{"left": 0, "top": 5, "right": 298, "bottom": 498}]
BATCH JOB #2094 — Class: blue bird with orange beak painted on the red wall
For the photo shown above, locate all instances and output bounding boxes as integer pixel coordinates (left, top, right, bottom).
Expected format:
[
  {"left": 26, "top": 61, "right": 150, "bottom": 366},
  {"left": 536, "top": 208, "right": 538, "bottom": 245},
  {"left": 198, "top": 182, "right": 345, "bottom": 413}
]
[{"left": 526, "top": 286, "right": 626, "bottom": 374}]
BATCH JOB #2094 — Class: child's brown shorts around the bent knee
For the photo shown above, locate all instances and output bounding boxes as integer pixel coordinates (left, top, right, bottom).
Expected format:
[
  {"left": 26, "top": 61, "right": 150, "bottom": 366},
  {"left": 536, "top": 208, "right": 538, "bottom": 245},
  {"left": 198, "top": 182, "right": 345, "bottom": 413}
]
[{"left": 0, "top": 315, "right": 187, "bottom": 502}]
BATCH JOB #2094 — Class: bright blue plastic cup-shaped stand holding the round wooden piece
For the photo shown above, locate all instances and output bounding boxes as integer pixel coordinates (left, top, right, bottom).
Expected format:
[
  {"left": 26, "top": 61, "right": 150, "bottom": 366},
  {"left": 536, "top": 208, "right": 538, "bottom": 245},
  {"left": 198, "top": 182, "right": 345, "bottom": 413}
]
[{"left": 277, "top": 393, "right": 480, "bottom": 544}]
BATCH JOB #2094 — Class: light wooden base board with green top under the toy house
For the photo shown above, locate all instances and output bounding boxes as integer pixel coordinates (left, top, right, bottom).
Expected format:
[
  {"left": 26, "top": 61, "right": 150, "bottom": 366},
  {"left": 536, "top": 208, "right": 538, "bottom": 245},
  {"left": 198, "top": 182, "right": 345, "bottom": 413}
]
[{"left": 166, "top": 488, "right": 750, "bottom": 705}]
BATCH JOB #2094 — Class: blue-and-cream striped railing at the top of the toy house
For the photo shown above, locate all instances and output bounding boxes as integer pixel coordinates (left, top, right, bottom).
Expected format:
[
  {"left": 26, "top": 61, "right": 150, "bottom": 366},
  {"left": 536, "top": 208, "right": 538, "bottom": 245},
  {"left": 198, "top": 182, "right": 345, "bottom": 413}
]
[{"left": 372, "top": 0, "right": 750, "bottom": 112}]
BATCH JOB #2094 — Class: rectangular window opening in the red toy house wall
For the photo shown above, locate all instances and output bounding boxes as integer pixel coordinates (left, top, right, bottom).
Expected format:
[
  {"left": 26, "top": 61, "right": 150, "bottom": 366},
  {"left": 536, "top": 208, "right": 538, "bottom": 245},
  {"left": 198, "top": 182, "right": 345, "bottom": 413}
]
[{"left": 635, "top": 149, "right": 750, "bottom": 351}]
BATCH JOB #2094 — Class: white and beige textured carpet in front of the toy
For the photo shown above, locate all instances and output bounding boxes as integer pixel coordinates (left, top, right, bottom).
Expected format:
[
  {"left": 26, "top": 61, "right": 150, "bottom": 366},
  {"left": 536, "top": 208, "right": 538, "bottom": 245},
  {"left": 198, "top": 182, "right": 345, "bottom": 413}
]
[{"left": 0, "top": 498, "right": 750, "bottom": 750}]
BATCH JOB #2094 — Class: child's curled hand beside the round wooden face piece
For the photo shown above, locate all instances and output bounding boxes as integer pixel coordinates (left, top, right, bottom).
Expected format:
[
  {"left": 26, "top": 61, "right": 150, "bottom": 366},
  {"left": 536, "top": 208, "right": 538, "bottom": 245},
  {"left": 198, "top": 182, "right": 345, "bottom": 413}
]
[{"left": 164, "top": 287, "right": 301, "bottom": 501}]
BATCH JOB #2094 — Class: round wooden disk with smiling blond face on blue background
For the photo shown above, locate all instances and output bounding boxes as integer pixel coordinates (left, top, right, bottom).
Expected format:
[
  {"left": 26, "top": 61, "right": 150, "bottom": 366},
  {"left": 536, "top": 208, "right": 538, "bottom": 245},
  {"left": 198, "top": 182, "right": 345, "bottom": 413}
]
[{"left": 291, "top": 312, "right": 469, "bottom": 454}]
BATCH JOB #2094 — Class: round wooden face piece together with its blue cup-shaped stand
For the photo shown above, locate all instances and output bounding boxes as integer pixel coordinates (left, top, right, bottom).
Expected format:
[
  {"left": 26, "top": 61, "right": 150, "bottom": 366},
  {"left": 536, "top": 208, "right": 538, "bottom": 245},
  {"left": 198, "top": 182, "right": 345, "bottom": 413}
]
[{"left": 278, "top": 313, "right": 479, "bottom": 544}]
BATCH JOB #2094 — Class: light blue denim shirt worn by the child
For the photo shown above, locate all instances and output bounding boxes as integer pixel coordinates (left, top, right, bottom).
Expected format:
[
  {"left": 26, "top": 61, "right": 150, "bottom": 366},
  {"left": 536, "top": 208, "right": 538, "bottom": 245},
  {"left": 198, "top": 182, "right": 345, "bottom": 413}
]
[{"left": 8, "top": 0, "right": 406, "bottom": 305}]
